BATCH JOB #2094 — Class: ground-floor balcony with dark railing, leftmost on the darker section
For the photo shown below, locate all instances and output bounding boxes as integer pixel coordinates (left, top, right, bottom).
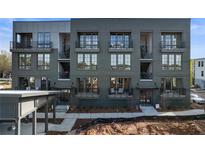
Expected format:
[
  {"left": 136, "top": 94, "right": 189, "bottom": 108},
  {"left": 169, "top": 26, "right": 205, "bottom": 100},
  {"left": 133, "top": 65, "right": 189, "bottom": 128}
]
[{"left": 75, "top": 88, "right": 100, "bottom": 99}]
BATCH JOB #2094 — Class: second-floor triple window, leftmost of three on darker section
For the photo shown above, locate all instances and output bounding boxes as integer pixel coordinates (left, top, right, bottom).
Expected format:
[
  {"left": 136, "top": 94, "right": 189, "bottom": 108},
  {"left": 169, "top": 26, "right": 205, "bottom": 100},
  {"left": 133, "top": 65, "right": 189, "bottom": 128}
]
[{"left": 77, "top": 54, "right": 97, "bottom": 70}]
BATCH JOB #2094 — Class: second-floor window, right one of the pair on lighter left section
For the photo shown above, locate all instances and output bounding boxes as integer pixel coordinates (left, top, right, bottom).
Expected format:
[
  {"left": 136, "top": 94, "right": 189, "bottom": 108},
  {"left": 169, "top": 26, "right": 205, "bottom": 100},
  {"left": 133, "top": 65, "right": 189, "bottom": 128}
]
[{"left": 38, "top": 54, "right": 50, "bottom": 70}]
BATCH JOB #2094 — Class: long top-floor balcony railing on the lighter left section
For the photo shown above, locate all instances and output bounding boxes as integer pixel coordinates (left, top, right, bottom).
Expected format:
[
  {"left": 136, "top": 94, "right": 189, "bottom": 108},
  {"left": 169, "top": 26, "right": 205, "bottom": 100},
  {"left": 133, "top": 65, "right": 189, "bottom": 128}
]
[{"left": 10, "top": 41, "right": 52, "bottom": 49}]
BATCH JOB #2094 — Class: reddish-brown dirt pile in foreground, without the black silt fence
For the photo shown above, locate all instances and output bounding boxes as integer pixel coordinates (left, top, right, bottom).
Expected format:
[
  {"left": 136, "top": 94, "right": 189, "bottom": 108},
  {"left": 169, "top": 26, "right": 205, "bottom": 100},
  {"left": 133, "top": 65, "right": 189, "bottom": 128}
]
[{"left": 79, "top": 120, "right": 205, "bottom": 135}]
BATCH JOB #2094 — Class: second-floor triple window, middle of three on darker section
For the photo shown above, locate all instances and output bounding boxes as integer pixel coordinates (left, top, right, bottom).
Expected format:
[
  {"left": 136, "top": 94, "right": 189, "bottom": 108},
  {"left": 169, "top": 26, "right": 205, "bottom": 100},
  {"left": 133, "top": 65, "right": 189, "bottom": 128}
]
[{"left": 111, "top": 54, "right": 131, "bottom": 70}]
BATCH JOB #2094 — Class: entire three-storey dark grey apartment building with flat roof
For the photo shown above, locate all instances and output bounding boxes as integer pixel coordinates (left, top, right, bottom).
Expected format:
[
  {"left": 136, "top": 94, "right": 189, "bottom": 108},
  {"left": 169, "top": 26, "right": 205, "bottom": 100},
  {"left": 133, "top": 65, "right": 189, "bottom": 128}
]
[{"left": 11, "top": 19, "right": 190, "bottom": 107}]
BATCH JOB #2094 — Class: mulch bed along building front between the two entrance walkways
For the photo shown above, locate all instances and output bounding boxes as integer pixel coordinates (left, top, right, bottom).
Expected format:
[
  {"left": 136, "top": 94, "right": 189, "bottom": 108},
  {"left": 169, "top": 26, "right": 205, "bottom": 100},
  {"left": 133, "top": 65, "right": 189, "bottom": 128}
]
[{"left": 67, "top": 107, "right": 141, "bottom": 113}]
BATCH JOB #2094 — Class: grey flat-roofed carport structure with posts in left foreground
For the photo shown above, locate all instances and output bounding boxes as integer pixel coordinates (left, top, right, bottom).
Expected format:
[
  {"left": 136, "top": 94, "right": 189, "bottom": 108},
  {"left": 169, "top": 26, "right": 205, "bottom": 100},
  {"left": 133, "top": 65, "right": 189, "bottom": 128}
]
[{"left": 0, "top": 90, "right": 60, "bottom": 135}]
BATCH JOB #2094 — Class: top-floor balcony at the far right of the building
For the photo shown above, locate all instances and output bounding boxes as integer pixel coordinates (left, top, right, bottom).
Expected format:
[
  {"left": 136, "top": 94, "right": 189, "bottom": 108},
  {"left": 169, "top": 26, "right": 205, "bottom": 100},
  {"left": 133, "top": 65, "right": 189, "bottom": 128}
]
[{"left": 160, "top": 41, "right": 186, "bottom": 52}]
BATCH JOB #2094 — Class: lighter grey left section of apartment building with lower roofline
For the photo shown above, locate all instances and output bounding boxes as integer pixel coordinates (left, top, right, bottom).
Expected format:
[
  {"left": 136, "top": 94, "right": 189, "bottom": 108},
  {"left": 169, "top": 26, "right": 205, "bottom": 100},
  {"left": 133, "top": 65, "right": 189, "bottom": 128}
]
[{"left": 10, "top": 21, "right": 70, "bottom": 89}]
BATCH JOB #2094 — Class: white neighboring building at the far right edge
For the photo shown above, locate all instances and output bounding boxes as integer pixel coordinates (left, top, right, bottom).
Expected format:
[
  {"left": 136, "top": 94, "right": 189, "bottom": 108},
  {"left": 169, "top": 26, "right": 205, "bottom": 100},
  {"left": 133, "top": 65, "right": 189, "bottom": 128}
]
[{"left": 194, "top": 58, "right": 205, "bottom": 89}]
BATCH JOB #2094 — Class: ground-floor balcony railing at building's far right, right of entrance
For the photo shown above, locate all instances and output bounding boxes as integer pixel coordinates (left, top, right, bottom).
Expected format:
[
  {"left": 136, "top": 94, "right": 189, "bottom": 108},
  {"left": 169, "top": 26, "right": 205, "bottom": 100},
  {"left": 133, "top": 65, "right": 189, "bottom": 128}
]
[{"left": 160, "top": 88, "right": 186, "bottom": 97}]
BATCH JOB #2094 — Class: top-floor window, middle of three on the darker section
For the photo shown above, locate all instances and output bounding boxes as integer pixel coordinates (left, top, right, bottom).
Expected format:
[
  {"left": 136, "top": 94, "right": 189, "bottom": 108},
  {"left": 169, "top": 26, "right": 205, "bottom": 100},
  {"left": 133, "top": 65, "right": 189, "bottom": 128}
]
[{"left": 110, "top": 32, "right": 131, "bottom": 48}]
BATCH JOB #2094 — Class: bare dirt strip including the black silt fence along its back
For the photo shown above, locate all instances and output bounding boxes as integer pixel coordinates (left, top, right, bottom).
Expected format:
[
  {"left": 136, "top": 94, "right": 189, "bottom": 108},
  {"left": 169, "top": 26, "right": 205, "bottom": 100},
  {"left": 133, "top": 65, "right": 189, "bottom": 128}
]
[{"left": 73, "top": 115, "right": 205, "bottom": 135}]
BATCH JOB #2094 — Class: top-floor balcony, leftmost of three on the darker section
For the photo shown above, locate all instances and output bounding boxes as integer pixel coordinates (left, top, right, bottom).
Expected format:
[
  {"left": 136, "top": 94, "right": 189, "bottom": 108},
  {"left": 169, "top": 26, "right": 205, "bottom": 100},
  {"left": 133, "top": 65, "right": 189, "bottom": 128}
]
[{"left": 75, "top": 41, "right": 100, "bottom": 52}]
